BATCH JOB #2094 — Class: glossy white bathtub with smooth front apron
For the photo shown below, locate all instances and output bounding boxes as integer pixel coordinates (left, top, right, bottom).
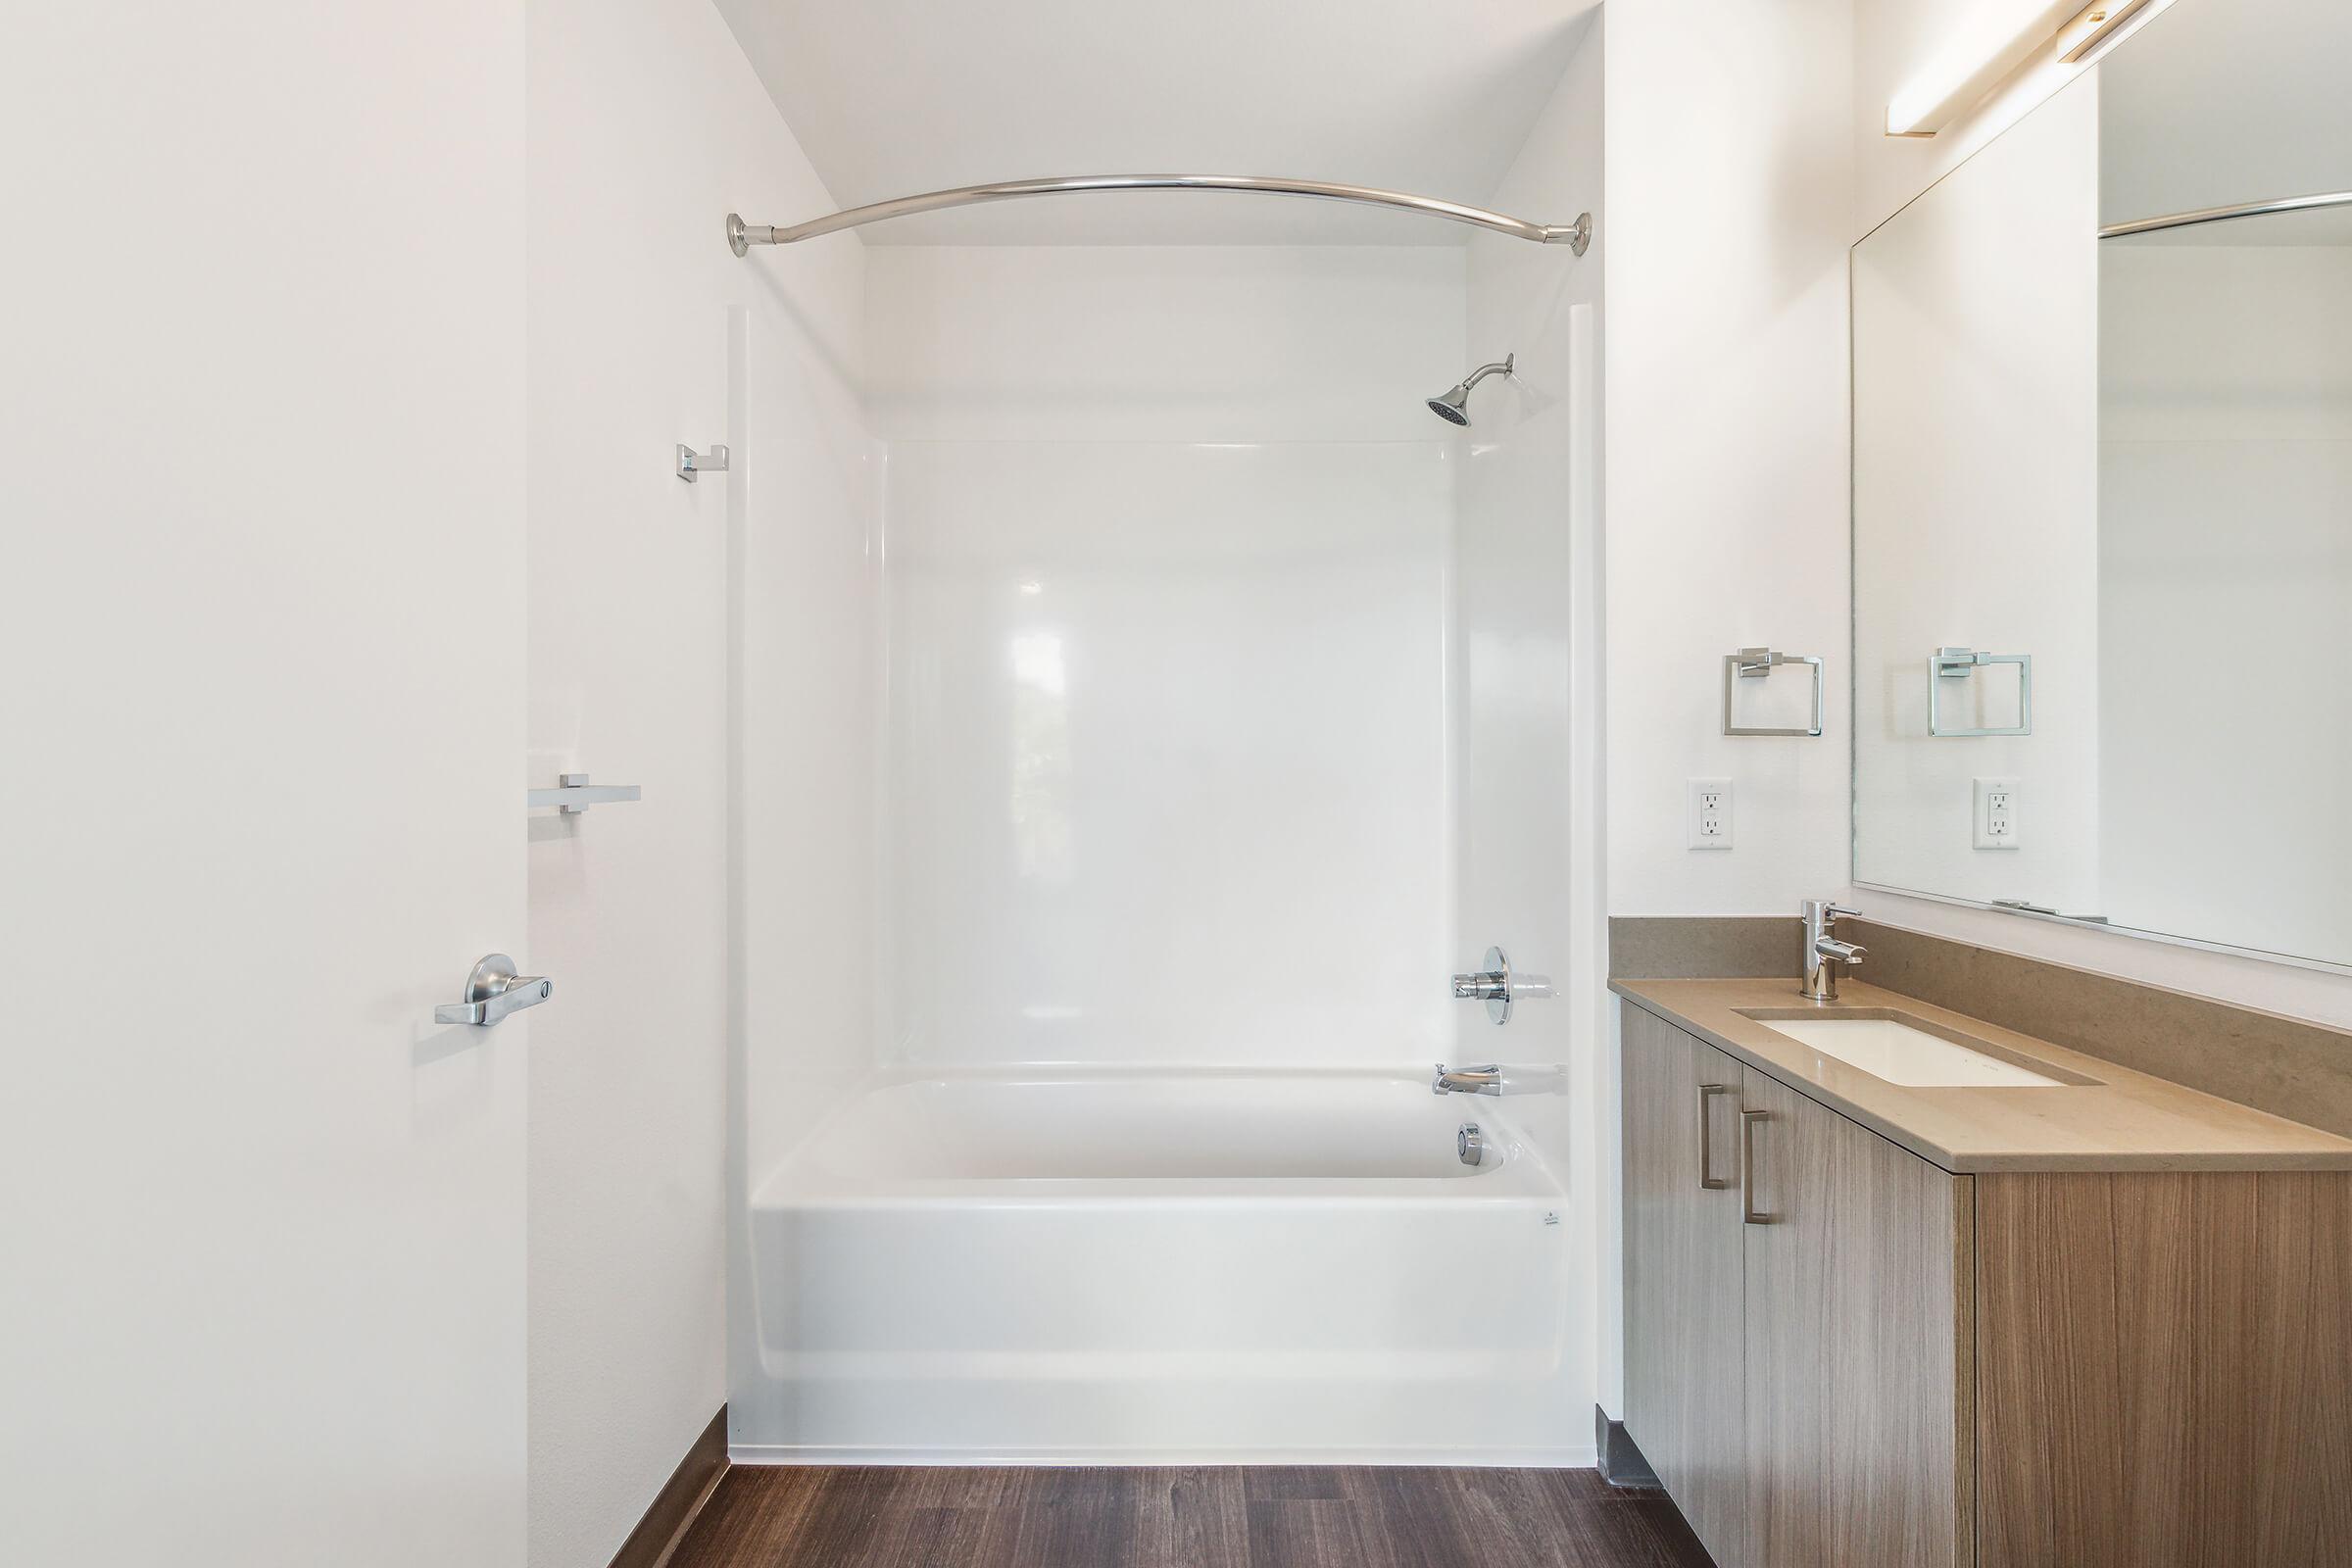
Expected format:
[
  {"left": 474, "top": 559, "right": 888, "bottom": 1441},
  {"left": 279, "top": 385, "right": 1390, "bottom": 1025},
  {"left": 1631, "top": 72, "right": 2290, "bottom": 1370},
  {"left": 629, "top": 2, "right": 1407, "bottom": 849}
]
[{"left": 734, "top": 1069, "right": 1590, "bottom": 1464}]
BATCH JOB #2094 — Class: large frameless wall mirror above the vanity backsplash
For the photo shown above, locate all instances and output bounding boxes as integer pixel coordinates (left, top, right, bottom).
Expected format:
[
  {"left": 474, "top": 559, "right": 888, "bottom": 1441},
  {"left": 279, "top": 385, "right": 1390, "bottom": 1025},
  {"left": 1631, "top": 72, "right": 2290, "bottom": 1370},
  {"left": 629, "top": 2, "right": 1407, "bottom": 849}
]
[{"left": 1853, "top": 0, "right": 2352, "bottom": 964}]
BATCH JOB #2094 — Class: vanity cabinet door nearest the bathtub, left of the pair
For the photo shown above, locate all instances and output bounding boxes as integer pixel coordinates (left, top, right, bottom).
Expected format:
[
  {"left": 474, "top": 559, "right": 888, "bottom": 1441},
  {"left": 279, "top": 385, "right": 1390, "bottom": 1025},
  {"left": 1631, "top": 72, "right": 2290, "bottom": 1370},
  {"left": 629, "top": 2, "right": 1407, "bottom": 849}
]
[{"left": 1623, "top": 1006, "right": 1745, "bottom": 1568}]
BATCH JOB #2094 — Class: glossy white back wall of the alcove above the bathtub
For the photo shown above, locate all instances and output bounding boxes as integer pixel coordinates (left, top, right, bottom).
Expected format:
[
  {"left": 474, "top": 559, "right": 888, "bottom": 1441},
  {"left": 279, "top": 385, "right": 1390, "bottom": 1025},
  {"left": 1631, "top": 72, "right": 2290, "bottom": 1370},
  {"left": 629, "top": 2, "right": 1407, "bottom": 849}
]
[{"left": 868, "top": 247, "right": 1468, "bottom": 1081}]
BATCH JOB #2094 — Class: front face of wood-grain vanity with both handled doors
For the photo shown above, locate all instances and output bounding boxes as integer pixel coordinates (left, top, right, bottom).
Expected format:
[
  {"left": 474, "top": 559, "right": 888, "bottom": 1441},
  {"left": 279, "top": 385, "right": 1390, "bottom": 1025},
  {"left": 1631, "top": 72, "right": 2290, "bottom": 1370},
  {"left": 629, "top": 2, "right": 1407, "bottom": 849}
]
[{"left": 1623, "top": 1008, "right": 1976, "bottom": 1568}]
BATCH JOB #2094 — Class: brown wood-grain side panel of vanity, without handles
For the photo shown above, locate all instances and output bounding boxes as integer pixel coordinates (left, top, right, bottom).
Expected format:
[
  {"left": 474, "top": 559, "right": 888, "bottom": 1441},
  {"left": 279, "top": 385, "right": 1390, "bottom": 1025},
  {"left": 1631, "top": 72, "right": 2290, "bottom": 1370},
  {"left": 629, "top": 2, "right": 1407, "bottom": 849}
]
[{"left": 1976, "top": 1171, "right": 2352, "bottom": 1568}]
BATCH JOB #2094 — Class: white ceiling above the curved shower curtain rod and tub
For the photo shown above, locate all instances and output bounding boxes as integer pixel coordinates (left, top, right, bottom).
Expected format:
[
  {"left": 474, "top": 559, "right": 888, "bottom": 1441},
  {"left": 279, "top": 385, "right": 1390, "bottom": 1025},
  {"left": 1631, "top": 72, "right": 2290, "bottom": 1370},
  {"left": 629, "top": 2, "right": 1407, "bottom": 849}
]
[{"left": 715, "top": 0, "right": 1597, "bottom": 244}]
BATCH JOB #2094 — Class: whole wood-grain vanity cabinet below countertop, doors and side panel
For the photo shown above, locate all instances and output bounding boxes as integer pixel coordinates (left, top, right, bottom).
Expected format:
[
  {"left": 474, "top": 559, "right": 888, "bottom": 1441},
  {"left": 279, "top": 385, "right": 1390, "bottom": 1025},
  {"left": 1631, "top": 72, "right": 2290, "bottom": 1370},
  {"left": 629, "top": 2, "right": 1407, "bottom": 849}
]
[{"left": 1623, "top": 1006, "right": 2352, "bottom": 1568}]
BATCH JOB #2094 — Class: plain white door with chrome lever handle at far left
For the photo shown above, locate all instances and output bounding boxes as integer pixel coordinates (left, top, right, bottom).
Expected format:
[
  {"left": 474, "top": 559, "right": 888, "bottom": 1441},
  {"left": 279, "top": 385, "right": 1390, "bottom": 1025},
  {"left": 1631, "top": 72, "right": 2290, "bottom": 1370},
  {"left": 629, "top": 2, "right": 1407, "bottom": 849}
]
[{"left": 0, "top": 0, "right": 531, "bottom": 1568}]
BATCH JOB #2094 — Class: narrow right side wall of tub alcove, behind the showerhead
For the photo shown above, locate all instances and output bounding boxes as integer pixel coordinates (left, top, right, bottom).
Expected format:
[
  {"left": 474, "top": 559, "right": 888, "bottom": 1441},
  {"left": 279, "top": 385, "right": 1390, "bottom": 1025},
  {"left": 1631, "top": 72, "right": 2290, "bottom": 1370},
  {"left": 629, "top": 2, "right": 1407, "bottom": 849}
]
[{"left": 1446, "top": 17, "right": 1623, "bottom": 1457}]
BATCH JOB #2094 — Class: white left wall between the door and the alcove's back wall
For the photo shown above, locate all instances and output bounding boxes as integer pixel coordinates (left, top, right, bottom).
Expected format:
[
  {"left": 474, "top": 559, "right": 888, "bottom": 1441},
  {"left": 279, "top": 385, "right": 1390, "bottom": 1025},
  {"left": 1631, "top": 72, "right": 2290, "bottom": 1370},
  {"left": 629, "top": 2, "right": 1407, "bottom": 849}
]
[{"left": 513, "top": 0, "right": 872, "bottom": 1568}]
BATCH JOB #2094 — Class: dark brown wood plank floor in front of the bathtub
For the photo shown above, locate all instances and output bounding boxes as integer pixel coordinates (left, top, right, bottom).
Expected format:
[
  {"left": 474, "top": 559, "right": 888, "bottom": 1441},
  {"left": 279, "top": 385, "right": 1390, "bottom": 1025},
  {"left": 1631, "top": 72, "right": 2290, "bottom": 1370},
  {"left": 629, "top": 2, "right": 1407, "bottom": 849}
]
[{"left": 670, "top": 1464, "right": 1710, "bottom": 1568}]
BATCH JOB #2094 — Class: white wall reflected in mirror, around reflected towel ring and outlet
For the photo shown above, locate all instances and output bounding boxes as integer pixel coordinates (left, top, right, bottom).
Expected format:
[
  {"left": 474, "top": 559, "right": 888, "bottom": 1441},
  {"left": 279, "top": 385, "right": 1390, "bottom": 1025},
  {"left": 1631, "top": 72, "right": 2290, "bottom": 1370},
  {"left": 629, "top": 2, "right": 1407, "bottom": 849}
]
[{"left": 1853, "top": 75, "right": 2105, "bottom": 914}]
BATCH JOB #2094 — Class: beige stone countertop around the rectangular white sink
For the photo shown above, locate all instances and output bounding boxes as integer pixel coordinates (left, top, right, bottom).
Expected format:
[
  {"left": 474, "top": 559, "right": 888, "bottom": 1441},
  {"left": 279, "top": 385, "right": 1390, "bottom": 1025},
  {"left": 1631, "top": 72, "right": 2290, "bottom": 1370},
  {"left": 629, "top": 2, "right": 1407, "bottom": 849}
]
[{"left": 1609, "top": 978, "right": 2352, "bottom": 1171}]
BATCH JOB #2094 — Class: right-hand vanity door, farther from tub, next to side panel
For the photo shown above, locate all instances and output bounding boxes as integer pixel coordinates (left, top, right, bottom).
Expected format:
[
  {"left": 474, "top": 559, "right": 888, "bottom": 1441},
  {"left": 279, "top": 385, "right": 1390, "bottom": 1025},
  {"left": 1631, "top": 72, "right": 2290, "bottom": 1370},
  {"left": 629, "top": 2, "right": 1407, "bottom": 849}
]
[{"left": 1740, "top": 1069, "right": 1976, "bottom": 1568}]
